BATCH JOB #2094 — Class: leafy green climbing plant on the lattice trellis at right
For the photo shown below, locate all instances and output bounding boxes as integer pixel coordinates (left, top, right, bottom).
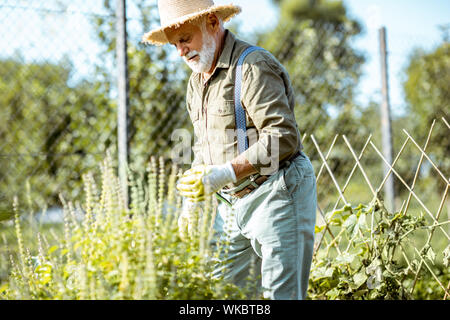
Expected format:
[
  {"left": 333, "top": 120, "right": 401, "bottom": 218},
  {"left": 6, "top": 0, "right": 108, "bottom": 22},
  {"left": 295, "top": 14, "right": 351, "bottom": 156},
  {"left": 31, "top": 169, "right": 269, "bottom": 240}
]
[{"left": 308, "top": 196, "right": 450, "bottom": 299}]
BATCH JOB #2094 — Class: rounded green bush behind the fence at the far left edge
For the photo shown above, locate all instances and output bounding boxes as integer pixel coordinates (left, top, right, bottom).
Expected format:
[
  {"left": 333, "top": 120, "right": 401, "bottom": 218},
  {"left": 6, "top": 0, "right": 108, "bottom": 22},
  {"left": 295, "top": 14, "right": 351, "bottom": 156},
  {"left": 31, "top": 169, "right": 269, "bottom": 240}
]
[{"left": 0, "top": 57, "right": 116, "bottom": 218}]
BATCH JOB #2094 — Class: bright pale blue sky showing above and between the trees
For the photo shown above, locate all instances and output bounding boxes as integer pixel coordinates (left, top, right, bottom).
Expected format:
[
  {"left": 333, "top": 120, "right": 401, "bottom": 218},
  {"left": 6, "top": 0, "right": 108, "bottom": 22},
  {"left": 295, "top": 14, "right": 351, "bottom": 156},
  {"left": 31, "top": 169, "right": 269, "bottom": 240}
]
[{"left": 0, "top": 0, "right": 450, "bottom": 115}]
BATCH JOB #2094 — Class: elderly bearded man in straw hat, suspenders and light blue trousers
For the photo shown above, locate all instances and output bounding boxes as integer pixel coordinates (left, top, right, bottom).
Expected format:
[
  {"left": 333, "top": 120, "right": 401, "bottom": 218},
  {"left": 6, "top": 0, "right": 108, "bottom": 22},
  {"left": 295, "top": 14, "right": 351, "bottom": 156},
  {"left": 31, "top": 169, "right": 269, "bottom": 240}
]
[{"left": 143, "top": 0, "right": 316, "bottom": 299}]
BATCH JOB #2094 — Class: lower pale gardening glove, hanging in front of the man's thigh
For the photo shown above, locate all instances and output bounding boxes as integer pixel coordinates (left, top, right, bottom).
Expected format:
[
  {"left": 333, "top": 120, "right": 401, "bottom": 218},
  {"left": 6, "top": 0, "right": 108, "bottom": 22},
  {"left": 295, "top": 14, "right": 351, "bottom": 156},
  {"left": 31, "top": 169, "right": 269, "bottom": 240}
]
[{"left": 178, "top": 198, "right": 203, "bottom": 241}]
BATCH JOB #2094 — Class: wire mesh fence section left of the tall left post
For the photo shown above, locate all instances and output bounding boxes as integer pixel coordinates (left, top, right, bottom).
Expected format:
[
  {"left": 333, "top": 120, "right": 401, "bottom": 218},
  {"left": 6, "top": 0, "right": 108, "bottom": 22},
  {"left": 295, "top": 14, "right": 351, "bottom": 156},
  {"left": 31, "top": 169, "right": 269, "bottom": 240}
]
[{"left": 0, "top": 1, "right": 116, "bottom": 214}]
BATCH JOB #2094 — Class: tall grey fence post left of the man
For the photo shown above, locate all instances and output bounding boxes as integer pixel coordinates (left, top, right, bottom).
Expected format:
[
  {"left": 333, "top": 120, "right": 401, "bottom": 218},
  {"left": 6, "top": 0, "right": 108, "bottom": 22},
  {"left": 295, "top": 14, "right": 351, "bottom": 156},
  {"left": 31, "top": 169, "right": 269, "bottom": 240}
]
[{"left": 116, "top": 0, "right": 129, "bottom": 207}]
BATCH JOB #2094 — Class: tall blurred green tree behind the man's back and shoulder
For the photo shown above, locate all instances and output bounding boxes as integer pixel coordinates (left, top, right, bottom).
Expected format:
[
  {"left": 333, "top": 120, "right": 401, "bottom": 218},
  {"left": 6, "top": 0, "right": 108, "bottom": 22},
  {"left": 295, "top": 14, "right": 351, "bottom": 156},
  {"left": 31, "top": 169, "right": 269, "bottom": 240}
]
[{"left": 258, "top": 0, "right": 364, "bottom": 140}]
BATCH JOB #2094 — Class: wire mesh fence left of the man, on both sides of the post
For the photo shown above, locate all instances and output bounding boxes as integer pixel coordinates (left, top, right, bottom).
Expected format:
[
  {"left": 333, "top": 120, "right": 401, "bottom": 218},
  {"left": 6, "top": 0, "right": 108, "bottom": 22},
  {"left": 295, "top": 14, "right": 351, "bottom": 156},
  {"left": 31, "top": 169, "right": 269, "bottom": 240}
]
[{"left": 0, "top": 1, "right": 192, "bottom": 216}]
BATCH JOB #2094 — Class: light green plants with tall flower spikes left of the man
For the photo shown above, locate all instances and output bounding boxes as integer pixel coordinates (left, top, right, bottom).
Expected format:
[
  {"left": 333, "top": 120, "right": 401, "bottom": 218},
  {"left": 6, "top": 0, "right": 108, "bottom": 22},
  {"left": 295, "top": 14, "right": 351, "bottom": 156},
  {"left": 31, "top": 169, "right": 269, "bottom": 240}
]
[{"left": 0, "top": 155, "right": 247, "bottom": 299}]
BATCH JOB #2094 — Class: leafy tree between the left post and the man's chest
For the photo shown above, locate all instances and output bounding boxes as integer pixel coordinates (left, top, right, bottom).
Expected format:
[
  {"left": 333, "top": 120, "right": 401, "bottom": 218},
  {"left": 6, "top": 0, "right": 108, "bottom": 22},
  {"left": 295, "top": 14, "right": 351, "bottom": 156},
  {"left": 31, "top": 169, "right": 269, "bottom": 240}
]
[{"left": 94, "top": 0, "right": 192, "bottom": 169}]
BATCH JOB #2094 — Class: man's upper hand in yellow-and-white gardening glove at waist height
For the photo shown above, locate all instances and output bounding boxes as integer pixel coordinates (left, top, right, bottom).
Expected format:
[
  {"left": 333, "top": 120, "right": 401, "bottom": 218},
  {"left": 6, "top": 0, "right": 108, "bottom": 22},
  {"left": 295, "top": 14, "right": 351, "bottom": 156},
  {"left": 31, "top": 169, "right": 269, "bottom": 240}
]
[{"left": 177, "top": 162, "right": 236, "bottom": 202}]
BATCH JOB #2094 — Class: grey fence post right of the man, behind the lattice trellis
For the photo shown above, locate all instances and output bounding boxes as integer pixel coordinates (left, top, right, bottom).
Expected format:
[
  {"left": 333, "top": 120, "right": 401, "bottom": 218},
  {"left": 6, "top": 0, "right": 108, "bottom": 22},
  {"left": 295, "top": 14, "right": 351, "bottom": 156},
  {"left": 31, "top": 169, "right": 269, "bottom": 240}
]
[{"left": 379, "top": 27, "right": 395, "bottom": 212}]
